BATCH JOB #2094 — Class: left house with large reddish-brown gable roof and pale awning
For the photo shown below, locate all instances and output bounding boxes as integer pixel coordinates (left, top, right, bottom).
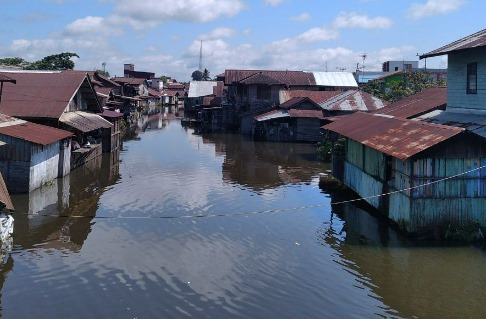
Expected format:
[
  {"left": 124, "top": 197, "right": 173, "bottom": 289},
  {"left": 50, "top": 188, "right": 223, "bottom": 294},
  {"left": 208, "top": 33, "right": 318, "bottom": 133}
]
[{"left": 0, "top": 70, "right": 112, "bottom": 168}]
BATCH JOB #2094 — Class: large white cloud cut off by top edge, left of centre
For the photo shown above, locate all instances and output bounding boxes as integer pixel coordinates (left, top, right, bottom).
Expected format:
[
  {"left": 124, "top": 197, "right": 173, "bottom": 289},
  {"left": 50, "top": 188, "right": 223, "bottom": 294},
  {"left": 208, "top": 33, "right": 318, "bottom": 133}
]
[{"left": 113, "top": 0, "right": 244, "bottom": 29}]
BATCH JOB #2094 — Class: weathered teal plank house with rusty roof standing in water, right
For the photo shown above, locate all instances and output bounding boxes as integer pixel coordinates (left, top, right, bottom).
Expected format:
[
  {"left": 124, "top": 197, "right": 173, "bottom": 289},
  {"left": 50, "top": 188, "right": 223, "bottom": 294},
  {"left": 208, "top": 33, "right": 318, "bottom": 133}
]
[{"left": 324, "top": 112, "right": 486, "bottom": 234}]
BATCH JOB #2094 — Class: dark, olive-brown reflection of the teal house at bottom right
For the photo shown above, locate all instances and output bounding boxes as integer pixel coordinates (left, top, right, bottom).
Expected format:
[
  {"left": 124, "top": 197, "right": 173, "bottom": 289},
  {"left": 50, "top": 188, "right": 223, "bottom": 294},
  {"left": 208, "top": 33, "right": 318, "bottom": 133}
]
[{"left": 316, "top": 179, "right": 486, "bottom": 318}]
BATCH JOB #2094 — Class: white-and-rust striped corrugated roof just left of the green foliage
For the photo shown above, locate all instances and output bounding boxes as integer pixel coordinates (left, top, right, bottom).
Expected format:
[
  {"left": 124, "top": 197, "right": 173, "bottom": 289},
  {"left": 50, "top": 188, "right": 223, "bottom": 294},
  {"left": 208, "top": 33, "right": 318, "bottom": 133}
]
[{"left": 320, "top": 90, "right": 388, "bottom": 112}]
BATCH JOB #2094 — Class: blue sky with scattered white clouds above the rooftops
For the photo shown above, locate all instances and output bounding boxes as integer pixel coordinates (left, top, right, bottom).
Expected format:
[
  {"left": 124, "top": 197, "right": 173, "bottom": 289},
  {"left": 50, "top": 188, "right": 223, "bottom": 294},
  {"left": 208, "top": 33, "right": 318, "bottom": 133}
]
[{"left": 0, "top": 0, "right": 486, "bottom": 82}]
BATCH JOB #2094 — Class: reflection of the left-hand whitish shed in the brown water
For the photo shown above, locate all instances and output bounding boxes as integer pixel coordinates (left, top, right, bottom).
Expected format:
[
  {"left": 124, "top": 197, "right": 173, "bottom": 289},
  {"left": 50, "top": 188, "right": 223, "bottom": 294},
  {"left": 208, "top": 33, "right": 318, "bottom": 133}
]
[{"left": 12, "top": 154, "right": 119, "bottom": 251}]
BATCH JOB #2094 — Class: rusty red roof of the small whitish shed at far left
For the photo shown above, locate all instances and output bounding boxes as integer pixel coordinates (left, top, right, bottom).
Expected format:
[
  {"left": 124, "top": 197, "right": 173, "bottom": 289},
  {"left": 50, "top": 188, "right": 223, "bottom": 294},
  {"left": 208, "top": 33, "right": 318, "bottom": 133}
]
[{"left": 0, "top": 121, "right": 73, "bottom": 145}]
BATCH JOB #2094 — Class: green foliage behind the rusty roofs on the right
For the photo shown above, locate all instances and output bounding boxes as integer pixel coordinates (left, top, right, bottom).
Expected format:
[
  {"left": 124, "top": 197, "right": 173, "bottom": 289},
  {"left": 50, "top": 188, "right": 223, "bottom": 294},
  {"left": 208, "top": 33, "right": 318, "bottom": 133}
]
[{"left": 362, "top": 71, "right": 446, "bottom": 102}]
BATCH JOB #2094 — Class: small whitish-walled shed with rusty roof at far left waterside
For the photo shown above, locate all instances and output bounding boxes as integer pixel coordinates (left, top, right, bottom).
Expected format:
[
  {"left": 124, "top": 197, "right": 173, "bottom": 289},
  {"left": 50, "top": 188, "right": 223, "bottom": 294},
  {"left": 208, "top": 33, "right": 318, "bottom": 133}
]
[{"left": 0, "top": 114, "right": 73, "bottom": 193}]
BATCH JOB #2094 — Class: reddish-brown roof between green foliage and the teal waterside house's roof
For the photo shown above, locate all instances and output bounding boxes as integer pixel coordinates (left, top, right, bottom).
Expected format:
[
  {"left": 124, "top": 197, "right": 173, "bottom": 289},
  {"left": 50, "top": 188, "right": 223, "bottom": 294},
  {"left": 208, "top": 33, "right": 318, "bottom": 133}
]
[{"left": 375, "top": 87, "right": 447, "bottom": 119}]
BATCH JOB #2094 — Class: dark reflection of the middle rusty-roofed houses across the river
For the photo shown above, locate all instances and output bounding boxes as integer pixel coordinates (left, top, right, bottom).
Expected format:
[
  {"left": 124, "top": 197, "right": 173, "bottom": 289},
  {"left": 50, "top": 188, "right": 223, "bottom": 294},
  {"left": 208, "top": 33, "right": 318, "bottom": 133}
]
[{"left": 199, "top": 134, "right": 324, "bottom": 190}]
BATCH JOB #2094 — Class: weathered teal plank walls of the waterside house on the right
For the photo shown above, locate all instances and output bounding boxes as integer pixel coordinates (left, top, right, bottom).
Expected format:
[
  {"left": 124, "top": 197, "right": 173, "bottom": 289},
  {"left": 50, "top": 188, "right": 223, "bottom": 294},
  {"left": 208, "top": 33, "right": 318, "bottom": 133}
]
[{"left": 343, "top": 134, "right": 486, "bottom": 233}]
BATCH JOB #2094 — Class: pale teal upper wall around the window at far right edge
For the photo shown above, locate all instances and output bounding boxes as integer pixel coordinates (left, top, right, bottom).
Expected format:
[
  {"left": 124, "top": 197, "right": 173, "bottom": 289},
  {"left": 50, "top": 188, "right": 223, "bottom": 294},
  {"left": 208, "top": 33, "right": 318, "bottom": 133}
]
[{"left": 447, "top": 47, "right": 486, "bottom": 110}]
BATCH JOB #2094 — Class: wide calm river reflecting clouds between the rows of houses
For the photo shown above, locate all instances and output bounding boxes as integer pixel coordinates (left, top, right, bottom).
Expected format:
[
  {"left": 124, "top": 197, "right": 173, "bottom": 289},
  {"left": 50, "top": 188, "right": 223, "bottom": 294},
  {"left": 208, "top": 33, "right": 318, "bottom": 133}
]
[{"left": 0, "top": 120, "right": 486, "bottom": 319}]
